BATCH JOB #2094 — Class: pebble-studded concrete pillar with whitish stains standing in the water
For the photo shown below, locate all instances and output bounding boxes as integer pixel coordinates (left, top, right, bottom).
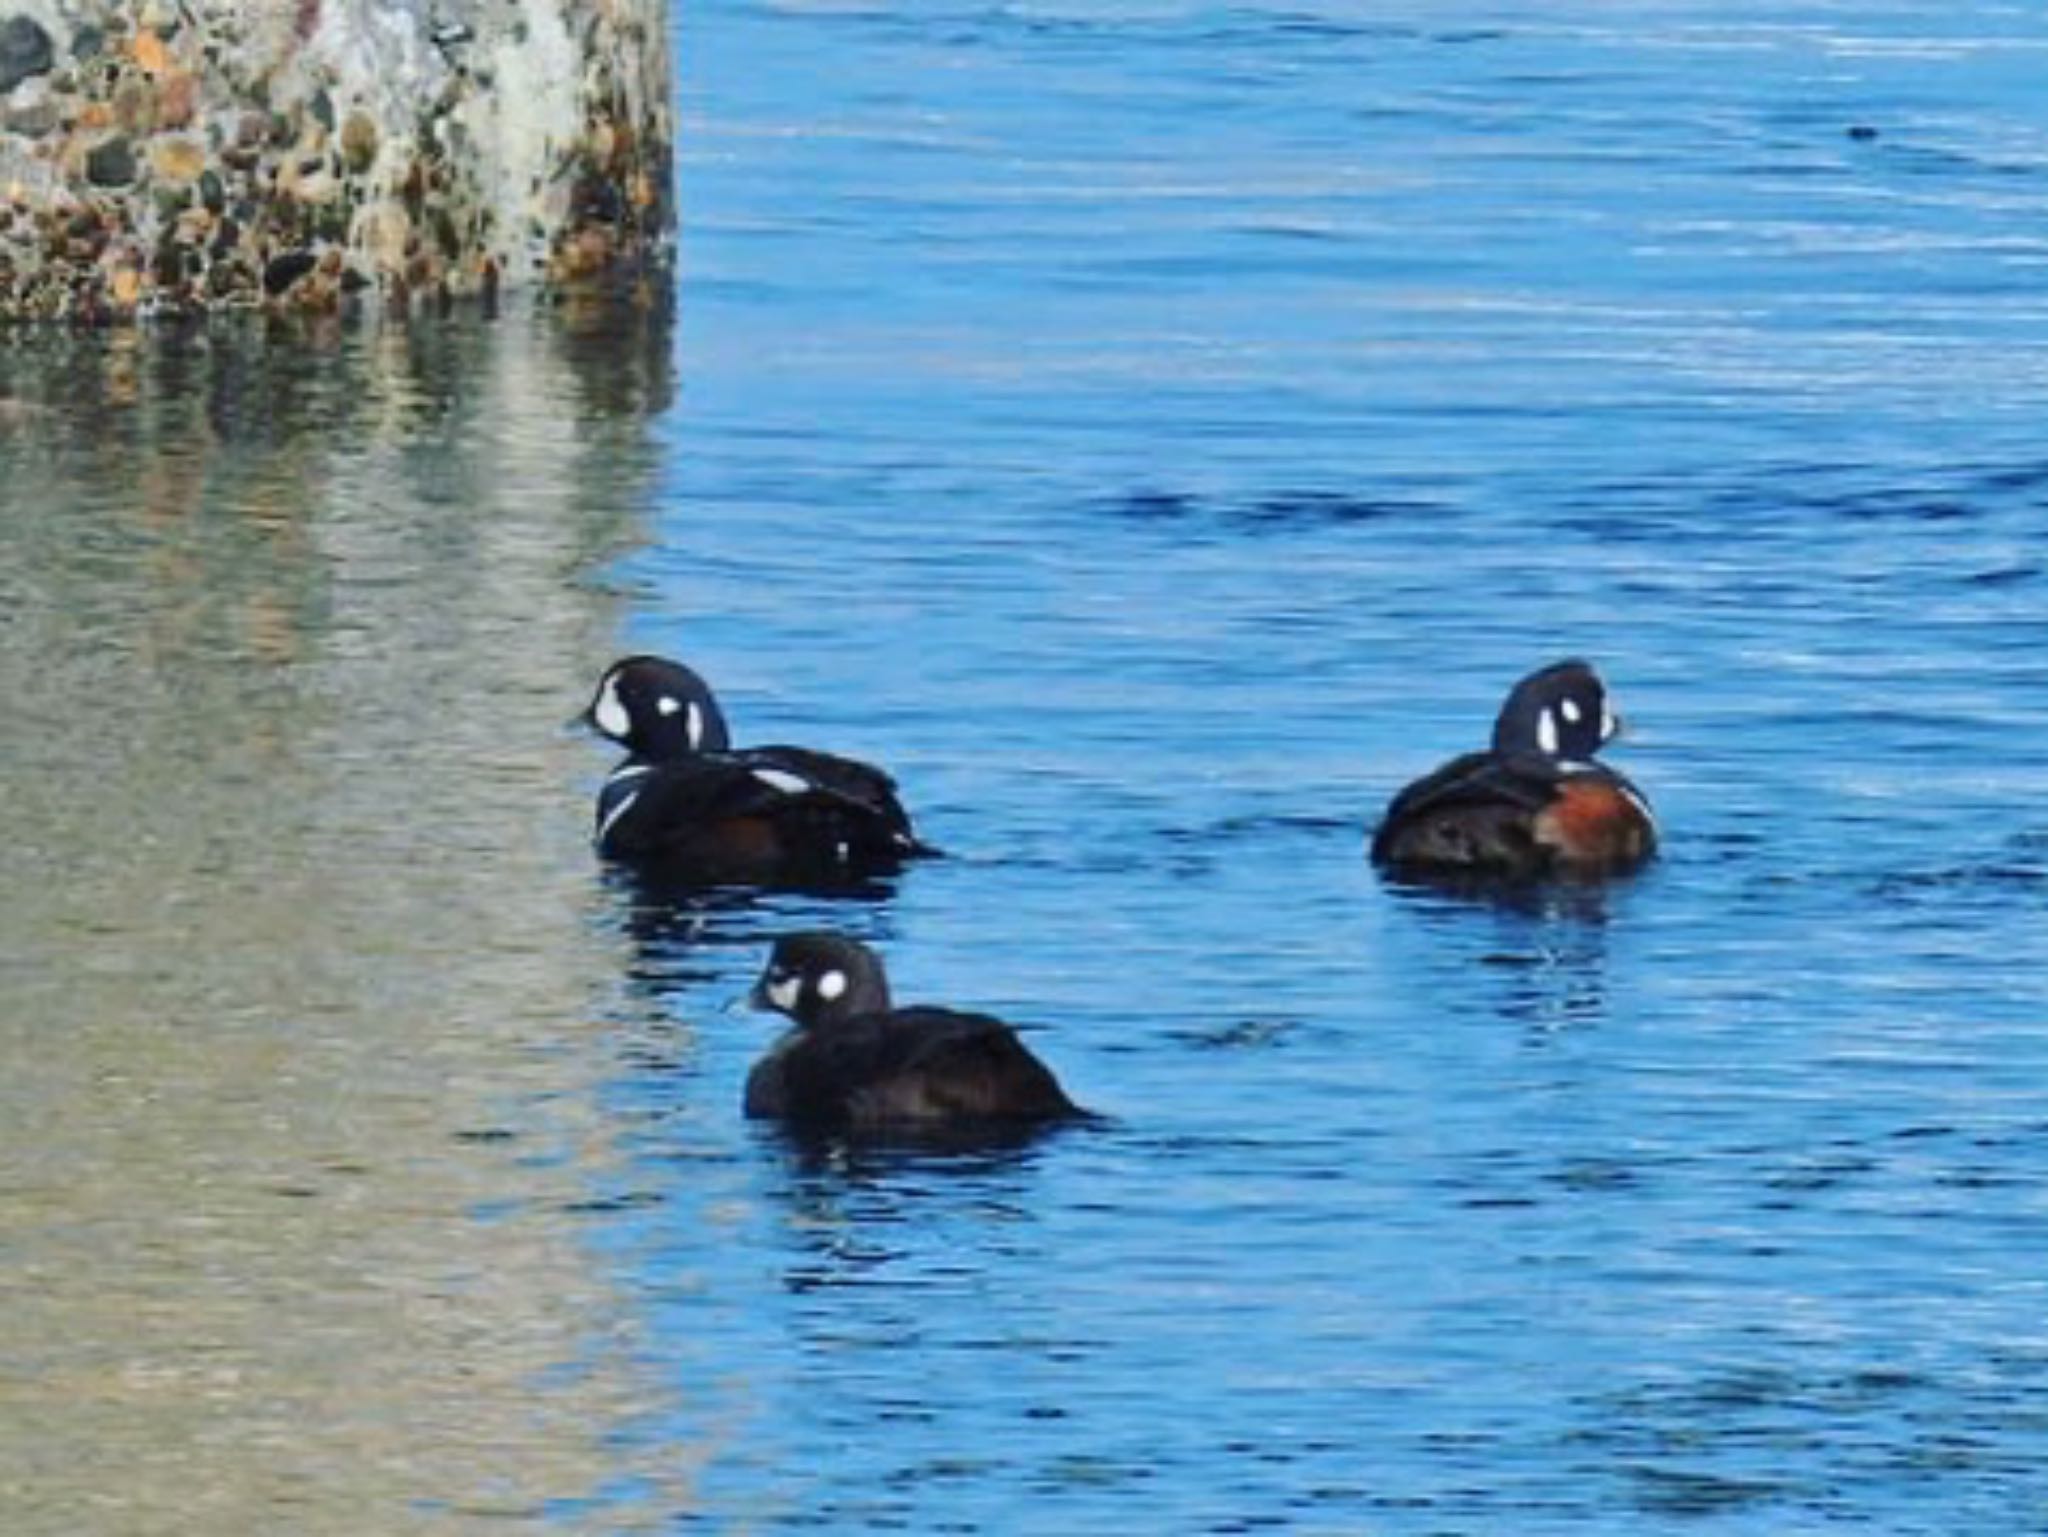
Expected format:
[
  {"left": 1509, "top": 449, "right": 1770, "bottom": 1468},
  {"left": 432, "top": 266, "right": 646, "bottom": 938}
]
[{"left": 0, "top": 0, "right": 674, "bottom": 322}]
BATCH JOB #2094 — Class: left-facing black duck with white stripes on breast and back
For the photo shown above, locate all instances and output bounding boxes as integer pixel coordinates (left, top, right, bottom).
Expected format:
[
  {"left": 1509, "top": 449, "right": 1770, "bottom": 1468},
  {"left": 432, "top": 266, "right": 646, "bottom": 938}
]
[{"left": 584, "top": 656, "right": 932, "bottom": 881}]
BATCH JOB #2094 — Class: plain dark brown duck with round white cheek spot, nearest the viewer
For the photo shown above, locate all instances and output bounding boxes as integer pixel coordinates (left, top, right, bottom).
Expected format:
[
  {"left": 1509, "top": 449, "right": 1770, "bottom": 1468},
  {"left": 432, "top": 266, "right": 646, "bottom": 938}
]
[{"left": 745, "top": 932, "right": 1085, "bottom": 1133}]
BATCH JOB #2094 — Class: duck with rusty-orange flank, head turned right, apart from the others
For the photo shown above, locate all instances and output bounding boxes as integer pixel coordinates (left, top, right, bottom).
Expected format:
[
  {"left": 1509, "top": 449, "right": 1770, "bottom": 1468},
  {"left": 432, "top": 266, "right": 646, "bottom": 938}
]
[{"left": 1372, "top": 660, "right": 1657, "bottom": 879}]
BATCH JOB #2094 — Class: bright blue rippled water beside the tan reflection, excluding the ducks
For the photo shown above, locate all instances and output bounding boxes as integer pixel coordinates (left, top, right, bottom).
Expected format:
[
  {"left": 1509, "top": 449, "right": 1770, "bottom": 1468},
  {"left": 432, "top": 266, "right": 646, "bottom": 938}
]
[{"left": 594, "top": 4, "right": 2048, "bottom": 1533}]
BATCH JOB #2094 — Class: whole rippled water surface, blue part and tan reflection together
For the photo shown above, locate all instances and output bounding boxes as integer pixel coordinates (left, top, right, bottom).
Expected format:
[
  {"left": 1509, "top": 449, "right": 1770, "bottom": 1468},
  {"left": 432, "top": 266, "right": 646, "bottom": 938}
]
[{"left": 12, "top": 0, "right": 2048, "bottom": 1537}]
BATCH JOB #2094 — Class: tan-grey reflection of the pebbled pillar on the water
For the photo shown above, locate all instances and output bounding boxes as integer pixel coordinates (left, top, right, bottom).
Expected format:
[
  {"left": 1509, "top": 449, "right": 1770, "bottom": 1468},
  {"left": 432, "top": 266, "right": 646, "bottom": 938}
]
[{"left": 0, "top": 314, "right": 670, "bottom": 1531}]
